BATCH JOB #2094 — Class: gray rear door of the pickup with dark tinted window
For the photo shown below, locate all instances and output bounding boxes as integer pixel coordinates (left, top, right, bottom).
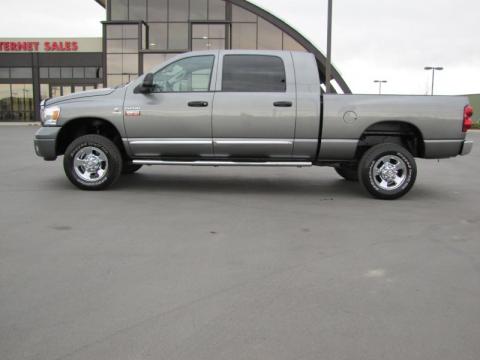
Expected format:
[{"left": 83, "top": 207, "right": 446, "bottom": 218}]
[{"left": 212, "top": 52, "right": 296, "bottom": 158}]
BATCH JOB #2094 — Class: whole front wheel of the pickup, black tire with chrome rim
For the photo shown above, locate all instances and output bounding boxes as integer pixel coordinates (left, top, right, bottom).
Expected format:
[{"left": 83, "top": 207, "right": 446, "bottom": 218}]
[{"left": 63, "top": 135, "right": 123, "bottom": 190}]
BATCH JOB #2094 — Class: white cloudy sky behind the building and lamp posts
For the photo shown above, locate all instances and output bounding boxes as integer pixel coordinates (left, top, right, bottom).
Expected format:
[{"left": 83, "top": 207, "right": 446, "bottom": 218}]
[{"left": 0, "top": 0, "right": 480, "bottom": 94}]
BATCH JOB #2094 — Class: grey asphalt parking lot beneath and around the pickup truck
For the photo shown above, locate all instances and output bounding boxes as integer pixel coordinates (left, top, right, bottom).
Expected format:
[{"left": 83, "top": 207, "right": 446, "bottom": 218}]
[{"left": 0, "top": 126, "right": 480, "bottom": 360}]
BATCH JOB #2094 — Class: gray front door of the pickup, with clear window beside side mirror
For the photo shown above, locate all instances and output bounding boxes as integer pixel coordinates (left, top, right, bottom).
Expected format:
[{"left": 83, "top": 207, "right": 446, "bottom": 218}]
[{"left": 124, "top": 52, "right": 216, "bottom": 157}]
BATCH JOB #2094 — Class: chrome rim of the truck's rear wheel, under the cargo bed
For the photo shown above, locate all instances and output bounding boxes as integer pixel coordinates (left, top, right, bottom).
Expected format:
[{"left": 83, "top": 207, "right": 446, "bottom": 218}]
[{"left": 372, "top": 155, "right": 408, "bottom": 191}]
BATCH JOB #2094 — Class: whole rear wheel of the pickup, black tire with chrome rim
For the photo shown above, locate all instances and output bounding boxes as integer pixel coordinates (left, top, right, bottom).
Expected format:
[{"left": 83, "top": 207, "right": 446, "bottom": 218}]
[{"left": 358, "top": 143, "right": 417, "bottom": 200}]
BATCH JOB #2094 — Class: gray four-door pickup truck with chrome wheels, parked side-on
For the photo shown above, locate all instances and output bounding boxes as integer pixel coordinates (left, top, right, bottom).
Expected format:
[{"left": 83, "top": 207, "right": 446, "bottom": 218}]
[{"left": 34, "top": 50, "right": 473, "bottom": 199}]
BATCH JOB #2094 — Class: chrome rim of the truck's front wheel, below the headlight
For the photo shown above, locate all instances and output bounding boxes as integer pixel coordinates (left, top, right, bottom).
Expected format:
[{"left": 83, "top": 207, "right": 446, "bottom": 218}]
[{"left": 73, "top": 146, "right": 108, "bottom": 182}]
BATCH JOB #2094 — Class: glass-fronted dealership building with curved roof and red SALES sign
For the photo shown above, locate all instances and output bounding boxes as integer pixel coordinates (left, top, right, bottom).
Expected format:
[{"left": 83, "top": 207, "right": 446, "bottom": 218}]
[{"left": 0, "top": 0, "right": 350, "bottom": 121}]
